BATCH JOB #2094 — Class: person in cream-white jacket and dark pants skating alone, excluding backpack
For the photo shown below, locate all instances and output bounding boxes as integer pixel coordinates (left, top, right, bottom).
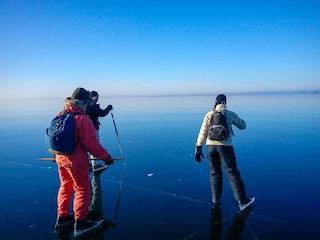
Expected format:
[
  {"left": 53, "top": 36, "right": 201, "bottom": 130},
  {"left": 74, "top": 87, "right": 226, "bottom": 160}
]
[{"left": 195, "top": 94, "right": 255, "bottom": 211}]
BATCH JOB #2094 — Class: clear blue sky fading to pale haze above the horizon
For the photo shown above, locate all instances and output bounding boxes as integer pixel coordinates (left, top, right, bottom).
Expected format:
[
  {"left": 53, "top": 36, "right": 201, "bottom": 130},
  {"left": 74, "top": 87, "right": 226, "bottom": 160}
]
[{"left": 0, "top": 0, "right": 320, "bottom": 99}]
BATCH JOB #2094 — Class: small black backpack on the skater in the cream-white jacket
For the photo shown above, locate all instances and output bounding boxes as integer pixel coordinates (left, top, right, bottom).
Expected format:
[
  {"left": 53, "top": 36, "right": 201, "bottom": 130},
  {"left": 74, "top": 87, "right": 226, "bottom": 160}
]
[{"left": 208, "top": 111, "right": 229, "bottom": 141}]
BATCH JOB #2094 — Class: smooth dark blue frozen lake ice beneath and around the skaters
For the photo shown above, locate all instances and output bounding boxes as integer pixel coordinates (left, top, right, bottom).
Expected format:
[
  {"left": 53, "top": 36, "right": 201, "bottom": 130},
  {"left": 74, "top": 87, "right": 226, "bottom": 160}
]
[{"left": 0, "top": 94, "right": 320, "bottom": 240}]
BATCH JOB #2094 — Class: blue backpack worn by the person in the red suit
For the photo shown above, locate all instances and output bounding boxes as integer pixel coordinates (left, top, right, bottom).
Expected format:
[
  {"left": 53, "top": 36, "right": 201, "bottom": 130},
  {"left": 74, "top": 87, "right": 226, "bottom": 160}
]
[{"left": 45, "top": 111, "right": 79, "bottom": 155}]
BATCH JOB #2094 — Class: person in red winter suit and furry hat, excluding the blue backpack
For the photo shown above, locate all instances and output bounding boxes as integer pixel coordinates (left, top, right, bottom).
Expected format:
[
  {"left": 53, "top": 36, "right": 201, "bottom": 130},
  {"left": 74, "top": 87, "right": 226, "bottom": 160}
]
[{"left": 55, "top": 88, "right": 113, "bottom": 229}]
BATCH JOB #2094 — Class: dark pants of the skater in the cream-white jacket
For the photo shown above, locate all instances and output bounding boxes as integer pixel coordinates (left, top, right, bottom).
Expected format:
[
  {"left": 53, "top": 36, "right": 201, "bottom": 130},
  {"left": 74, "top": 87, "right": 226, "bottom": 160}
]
[{"left": 207, "top": 145, "right": 247, "bottom": 203}]
